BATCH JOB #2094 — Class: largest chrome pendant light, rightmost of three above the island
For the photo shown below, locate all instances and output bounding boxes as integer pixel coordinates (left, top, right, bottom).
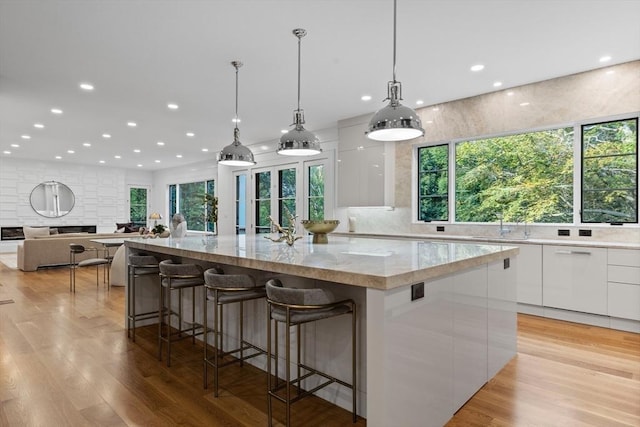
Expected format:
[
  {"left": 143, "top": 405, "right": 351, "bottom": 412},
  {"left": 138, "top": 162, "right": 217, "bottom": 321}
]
[{"left": 365, "top": 0, "right": 424, "bottom": 141}]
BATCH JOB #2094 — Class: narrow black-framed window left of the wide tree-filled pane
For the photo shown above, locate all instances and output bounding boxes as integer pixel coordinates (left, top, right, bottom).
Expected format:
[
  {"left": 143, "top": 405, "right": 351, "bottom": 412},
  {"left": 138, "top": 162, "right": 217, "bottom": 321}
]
[{"left": 418, "top": 144, "right": 449, "bottom": 221}]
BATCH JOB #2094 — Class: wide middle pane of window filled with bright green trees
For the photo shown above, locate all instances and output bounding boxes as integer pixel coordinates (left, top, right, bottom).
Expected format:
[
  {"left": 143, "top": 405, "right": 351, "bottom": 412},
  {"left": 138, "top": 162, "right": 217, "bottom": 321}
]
[{"left": 456, "top": 127, "right": 574, "bottom": 223}]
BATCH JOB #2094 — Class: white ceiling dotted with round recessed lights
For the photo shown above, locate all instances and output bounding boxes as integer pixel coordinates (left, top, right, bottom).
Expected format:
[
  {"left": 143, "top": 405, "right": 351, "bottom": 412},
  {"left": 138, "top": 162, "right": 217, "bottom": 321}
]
[{"left": 0, "top": 0, "right": 640, "bottom": 170}]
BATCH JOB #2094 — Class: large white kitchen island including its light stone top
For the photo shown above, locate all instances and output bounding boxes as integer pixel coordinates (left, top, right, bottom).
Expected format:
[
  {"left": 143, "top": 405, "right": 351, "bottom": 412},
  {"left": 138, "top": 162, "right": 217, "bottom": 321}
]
[{"left": 125, "top": 235, "right": 518, "bottom": 427}]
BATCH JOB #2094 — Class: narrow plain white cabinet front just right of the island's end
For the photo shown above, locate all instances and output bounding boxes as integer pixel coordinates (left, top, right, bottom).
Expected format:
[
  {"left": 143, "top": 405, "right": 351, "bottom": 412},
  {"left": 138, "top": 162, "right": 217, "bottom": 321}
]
[{"left": 513, "top": 245, "right": 542, "bottom": 305}]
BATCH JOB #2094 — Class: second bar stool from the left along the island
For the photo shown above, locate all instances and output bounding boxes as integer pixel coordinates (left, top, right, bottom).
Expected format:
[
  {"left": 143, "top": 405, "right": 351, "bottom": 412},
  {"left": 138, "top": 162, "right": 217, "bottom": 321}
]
[{"left": 158, "top": 259, "right": 204, "bottom": 366}]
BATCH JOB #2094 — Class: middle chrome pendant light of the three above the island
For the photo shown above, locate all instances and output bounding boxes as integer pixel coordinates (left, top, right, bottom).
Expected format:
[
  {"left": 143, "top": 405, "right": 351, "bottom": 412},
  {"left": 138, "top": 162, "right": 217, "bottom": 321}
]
[{"left": 278, "top": 28, "right": 322, "bottom": 156}]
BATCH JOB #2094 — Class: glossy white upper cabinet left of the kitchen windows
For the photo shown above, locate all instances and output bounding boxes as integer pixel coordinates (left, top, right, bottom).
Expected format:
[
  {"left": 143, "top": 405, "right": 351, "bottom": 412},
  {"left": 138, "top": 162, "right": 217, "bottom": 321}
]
[{"left": 337, "top": 120, "right": 395, "bottom": 206}]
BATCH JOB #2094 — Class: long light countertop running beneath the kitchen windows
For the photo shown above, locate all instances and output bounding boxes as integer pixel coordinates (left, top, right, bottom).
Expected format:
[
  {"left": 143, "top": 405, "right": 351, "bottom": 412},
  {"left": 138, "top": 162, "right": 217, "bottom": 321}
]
[{"left": 331, "top": 232, "right": 640, "bottom": 250}]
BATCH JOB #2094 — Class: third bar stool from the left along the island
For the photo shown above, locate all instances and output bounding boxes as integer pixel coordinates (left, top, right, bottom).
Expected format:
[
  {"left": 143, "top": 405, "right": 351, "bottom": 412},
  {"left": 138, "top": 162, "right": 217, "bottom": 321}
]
[{"left": 203, "top": 268, "right": 266, "bottom": 397}]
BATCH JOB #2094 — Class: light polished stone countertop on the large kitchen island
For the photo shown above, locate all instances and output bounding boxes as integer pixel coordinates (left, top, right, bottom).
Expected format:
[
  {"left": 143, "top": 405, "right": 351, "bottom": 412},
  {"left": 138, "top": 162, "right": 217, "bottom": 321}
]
[{"left": 125, "top": 235, "right": 519, "bottom": 290}]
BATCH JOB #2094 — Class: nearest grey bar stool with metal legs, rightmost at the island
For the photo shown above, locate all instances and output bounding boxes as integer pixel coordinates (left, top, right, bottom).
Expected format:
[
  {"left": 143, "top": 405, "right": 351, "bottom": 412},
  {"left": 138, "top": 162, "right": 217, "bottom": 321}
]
[{"left": 266, "top": 279, "right": 357, "bottom": 427}]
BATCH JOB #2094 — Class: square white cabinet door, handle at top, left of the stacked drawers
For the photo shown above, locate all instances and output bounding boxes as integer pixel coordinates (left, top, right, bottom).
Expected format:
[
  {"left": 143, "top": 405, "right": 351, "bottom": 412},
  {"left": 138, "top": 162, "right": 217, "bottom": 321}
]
[{"left": 542, "top": 245, "right": 607, "bottom": 315}]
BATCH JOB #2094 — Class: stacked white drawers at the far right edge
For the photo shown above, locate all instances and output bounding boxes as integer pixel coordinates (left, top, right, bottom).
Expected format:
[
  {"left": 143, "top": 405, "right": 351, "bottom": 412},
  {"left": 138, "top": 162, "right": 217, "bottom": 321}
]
[{"left": 607, "top": 249, "right": 640, "bottom": 320}]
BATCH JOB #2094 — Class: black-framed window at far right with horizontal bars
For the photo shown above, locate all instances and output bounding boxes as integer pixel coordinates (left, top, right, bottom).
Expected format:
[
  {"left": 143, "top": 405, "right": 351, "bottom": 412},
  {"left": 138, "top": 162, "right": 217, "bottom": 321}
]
[{"left": 581, "top": 118, "right": 638, "bottom": 223}]
